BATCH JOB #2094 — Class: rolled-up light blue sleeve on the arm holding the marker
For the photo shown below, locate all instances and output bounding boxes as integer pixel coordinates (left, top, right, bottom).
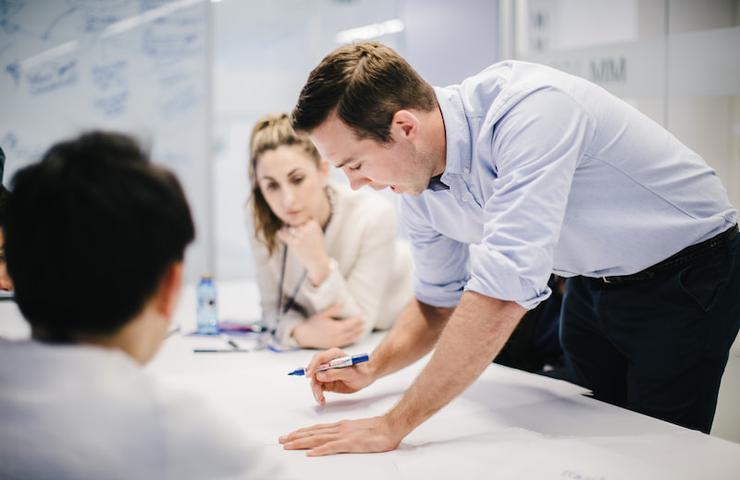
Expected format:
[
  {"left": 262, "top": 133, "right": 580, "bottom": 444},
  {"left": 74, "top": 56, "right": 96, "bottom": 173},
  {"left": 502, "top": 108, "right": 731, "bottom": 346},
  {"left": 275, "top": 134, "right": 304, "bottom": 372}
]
[{"left": 401, "top": 196, "right": 470, "bottom": 307}]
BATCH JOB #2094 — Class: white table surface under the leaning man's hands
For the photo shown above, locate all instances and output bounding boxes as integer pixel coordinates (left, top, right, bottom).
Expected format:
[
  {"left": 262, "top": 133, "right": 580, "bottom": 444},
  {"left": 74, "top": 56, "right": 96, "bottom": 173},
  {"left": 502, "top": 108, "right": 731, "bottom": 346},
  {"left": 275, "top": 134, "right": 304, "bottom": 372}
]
[{"left": 0, "top": 284, "right": 740, "bottom": 480}]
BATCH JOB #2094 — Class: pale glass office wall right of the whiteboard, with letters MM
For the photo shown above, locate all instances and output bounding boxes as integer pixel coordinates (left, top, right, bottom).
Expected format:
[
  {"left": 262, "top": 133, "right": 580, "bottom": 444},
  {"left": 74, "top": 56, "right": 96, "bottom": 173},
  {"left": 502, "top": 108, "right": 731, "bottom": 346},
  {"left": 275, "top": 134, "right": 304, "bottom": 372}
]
[{"left": 208, "top": 0, "right": 740, "bottom": 284}]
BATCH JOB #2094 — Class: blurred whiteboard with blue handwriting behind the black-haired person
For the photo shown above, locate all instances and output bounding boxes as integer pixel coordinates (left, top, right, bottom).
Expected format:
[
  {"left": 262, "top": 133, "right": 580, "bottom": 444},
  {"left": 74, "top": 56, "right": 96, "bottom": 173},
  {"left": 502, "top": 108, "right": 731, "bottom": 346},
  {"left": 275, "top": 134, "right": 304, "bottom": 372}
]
[{"left": 0, "top": 0, "right": 213, "bottom": 279}]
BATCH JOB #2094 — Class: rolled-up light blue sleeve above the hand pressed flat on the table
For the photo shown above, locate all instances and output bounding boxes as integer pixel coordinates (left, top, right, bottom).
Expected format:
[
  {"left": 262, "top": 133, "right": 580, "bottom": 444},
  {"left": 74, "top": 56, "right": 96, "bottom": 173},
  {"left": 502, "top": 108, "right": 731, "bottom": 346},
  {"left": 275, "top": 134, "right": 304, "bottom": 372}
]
[{"left": 465, "top": 89, "right": 594, "bottom": 309}]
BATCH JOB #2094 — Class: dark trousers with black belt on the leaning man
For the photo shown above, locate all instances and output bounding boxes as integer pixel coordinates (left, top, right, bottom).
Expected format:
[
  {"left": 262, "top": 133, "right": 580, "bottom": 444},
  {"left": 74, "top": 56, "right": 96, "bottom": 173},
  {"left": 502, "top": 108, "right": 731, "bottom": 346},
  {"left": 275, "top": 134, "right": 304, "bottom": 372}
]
[{"left": 560, "top": 227, "right": 740, "bottom": 433}]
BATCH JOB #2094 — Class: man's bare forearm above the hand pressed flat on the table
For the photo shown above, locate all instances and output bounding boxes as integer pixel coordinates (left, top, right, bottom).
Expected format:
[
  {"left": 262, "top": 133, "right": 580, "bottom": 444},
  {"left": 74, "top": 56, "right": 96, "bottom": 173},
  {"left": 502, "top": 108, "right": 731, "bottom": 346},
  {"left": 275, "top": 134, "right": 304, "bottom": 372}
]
[{"left": 387, "top": 292, "right": 526, "bottom": 436}]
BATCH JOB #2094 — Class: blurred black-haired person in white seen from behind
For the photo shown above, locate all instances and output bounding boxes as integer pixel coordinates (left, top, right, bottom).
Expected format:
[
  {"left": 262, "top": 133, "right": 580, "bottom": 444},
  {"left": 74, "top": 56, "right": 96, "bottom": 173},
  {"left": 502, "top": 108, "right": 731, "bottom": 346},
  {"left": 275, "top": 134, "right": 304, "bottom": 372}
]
[{"left": 0, "top": 132, "right": 271, "bottom": 479}]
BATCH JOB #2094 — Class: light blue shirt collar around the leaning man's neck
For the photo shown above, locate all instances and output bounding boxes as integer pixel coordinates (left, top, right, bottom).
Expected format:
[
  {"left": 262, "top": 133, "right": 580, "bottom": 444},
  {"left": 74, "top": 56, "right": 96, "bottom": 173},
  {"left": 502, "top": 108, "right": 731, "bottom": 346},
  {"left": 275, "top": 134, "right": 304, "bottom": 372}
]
[{"left": 430, "top": 85, "right": 471, "bottom": 185}]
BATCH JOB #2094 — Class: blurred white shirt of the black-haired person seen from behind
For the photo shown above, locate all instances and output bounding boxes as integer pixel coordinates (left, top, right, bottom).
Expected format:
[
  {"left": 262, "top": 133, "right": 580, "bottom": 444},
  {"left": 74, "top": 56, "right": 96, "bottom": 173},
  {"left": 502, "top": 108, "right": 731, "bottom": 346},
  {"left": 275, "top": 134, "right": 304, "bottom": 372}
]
[{"left": 0, "top": 340, "right": 276, "bottom": 480}]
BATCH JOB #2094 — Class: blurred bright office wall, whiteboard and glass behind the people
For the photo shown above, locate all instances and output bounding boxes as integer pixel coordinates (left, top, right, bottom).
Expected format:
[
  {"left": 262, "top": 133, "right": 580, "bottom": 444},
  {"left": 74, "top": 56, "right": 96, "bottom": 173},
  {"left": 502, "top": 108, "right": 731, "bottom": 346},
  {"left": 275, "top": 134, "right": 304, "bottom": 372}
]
[{"left": 0, "top": 0, "right": 740, "bottom": 441}]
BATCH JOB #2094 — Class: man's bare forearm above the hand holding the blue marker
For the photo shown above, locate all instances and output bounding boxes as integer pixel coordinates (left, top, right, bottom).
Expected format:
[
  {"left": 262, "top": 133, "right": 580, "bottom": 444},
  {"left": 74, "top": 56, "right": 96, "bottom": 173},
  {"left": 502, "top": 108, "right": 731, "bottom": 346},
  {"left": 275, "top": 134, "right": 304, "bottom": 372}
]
[{"left": 370, "top": 299, "right": 453, "bottom": 378}]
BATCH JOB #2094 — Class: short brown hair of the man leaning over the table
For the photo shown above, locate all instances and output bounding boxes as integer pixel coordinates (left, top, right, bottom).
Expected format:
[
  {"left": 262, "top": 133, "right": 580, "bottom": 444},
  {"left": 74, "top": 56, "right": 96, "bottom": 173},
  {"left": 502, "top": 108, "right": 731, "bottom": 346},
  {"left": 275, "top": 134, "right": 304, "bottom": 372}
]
[{"left": 291, "top": 42, "right": 437, "bottom": 143}]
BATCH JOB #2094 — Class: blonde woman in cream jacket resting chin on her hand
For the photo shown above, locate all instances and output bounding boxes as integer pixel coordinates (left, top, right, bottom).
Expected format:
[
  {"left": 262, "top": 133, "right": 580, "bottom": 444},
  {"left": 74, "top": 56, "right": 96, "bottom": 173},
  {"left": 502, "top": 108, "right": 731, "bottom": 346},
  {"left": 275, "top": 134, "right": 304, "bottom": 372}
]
[{"left": 247, "top": 114, "right": 412, "bottom": 349}]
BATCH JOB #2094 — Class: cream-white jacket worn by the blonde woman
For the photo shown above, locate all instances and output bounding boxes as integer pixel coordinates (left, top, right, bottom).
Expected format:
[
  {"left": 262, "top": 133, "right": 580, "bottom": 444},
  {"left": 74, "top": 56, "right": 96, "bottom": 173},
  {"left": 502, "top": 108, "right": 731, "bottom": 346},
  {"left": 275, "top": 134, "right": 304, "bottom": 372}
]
[{"left": 246, "top": 185, "right": 413, "bottom": 345}]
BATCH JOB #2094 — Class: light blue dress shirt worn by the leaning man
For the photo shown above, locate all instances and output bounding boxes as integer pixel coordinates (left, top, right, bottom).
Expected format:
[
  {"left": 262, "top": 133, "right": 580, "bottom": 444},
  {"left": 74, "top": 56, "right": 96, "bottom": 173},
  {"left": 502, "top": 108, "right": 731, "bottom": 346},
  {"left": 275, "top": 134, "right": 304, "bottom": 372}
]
[{"left": 401, "top": 61, "right": 737, "bottom": 308}]
